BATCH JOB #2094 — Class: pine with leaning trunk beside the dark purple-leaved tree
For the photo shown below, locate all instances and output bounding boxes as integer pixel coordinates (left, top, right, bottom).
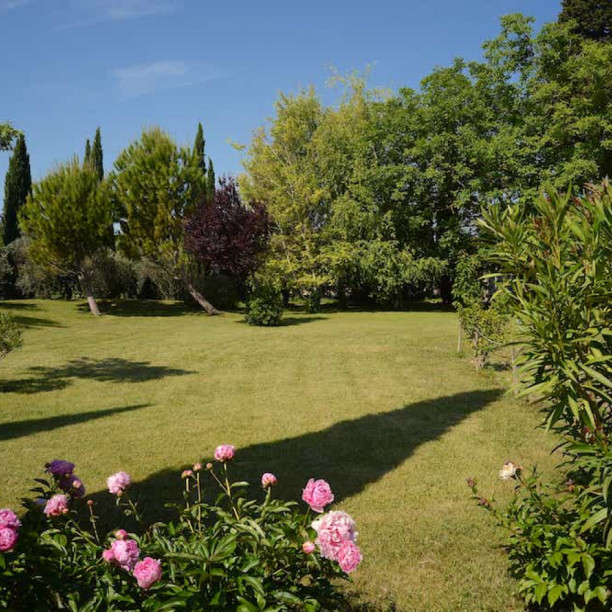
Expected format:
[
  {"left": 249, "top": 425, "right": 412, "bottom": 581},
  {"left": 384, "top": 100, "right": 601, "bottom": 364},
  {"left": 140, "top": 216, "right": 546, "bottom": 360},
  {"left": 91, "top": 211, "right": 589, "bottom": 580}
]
[{"left": 110, "top": 128, "right": 217, "bottom": 314}]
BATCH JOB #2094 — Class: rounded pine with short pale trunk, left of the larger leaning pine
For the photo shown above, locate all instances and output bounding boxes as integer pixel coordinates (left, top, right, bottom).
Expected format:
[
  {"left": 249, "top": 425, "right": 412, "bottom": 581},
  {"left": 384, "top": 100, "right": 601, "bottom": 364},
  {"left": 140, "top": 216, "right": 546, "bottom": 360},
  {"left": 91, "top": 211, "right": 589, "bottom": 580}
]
[{"left": 19, "top": 158, "right": 113, "bottom": 315}]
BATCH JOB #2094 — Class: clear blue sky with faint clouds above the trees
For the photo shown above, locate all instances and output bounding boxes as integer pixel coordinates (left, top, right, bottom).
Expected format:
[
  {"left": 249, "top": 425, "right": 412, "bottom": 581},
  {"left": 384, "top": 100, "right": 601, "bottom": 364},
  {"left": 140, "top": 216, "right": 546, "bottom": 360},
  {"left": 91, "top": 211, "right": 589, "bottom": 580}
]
[{"left": 0, "top": 0, "right": 560, "bottom": 192}]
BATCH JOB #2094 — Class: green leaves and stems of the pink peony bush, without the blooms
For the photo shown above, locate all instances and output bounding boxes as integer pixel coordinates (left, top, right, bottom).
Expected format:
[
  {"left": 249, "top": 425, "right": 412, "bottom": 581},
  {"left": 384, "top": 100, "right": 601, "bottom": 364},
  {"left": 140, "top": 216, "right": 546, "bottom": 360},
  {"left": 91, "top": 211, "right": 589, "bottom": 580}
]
[{"left": 0, "top": 463, "right": 348, "bottom": 612}]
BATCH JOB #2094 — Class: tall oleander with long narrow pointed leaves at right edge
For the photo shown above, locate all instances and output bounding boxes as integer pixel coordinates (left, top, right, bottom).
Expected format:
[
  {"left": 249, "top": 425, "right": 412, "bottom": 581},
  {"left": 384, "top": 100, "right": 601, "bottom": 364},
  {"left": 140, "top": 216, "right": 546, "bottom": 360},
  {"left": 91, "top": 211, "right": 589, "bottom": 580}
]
[{"left": 482, "top": 182, "right": 612, "bottom": 433}]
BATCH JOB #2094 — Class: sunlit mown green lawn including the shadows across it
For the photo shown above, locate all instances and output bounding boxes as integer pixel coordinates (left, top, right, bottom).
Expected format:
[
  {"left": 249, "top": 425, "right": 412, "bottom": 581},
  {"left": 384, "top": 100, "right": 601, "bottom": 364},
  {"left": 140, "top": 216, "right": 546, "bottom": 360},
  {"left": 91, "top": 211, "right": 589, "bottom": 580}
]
[{"left": 0, "top": 301, "right": 553, "bottom": 611}]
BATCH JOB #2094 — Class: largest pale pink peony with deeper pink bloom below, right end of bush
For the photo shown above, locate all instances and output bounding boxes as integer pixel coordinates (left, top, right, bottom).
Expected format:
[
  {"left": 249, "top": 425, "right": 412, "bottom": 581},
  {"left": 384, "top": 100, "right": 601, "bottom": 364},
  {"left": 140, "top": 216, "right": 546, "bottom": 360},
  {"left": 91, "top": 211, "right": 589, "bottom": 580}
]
[{"left": 312, "top": 511, "right": 362, "bottom": 574}]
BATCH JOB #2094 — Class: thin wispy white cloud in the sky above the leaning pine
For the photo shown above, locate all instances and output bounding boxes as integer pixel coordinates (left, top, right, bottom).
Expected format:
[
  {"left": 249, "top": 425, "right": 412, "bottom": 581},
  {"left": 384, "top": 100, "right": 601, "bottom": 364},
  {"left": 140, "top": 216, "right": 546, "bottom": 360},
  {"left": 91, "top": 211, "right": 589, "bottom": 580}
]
[{"left": 111, "top": 60, "right": 226, "bottom": 98}]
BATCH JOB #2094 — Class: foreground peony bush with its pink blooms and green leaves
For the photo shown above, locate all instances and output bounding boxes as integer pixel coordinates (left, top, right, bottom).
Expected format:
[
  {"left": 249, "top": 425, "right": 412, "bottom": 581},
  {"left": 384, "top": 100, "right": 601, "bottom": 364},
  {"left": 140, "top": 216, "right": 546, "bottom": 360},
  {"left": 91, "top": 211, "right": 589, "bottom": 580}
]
[{"left": 0, "top": 445, "right": 361, "bottom": 611}]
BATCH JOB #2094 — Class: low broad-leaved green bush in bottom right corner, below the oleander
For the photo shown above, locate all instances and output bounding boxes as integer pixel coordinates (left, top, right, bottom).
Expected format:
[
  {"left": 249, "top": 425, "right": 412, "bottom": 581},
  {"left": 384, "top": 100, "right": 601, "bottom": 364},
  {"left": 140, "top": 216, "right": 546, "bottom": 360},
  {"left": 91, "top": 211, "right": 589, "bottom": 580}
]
[{"left": 470, "top": 470, "right": 612, "bottom": 612}]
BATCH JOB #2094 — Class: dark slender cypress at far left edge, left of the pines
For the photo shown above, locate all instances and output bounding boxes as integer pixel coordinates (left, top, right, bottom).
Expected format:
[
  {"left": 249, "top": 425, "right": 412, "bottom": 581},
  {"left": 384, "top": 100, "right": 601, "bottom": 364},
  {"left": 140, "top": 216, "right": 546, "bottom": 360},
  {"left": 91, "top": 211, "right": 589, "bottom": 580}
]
[{"left": 3, "top": 134, "right": 32, "bottom": 245}]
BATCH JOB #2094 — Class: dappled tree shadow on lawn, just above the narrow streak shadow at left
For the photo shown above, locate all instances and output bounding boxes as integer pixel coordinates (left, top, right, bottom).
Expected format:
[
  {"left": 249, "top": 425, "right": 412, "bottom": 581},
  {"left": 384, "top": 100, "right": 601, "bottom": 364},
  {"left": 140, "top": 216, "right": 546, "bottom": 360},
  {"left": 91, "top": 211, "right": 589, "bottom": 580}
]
[{"left": 0, "top": 357, "right": 195, "bottom": 394}]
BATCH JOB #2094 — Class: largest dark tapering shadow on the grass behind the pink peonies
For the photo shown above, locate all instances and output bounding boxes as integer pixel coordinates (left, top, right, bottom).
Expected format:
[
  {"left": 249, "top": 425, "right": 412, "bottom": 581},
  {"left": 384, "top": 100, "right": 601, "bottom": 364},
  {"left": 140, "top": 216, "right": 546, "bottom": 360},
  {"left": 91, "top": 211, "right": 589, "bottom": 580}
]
[{"left": 94, "top": 389, "right": 501, "bottom": 521}]
